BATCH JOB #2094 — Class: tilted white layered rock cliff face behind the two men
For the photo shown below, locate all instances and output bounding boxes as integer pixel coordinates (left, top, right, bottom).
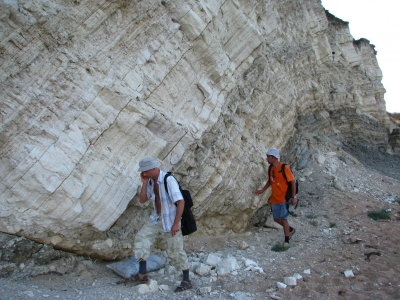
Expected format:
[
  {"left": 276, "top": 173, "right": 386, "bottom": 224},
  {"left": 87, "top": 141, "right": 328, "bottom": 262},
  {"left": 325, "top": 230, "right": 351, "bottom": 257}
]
[{"left": 0, "top": 0, "right": 393, "bottom": 259}]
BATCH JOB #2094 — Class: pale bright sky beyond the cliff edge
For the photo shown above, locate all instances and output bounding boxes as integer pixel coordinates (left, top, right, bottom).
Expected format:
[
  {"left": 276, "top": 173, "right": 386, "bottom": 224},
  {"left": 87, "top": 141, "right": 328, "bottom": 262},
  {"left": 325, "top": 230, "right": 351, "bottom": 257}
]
[{"left": 321, "top": 0, "right": 400, "bottom": 113}]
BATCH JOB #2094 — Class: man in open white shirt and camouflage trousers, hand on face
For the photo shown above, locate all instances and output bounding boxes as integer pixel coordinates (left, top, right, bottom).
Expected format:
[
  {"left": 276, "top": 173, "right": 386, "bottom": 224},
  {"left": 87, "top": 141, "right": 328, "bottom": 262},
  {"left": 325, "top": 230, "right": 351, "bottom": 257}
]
[{"left": 128, "top": 157, "right": 192, "bottom": 292}]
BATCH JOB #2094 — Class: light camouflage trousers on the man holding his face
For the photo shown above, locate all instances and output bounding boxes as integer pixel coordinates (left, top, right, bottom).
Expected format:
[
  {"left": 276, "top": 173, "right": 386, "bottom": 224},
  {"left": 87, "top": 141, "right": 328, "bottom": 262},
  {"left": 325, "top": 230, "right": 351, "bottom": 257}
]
[{"left": 134, "top": 220, "right": 189, "bottom": 270}]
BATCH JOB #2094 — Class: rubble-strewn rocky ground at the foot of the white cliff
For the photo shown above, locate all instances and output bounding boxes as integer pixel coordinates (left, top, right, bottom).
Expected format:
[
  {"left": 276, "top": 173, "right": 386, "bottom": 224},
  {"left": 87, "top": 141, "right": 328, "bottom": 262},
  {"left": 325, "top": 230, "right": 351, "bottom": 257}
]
[{"left": 0, "top": 137, "right": 400, "bottom": 300}]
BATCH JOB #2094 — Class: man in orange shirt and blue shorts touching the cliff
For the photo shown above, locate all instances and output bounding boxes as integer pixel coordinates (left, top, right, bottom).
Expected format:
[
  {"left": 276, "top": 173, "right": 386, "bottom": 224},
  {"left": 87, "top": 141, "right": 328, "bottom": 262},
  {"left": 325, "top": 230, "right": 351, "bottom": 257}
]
[{"left": 255, "top": 148, "right": 297, "bottom": 247}]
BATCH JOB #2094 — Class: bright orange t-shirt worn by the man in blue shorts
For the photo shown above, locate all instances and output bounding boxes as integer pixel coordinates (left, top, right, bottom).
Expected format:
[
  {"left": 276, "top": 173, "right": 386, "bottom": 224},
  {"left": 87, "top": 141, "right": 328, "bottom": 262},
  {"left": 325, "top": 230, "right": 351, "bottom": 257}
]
[{"left": 268, "top": 162, "right": 295, "bottom": 204}]
